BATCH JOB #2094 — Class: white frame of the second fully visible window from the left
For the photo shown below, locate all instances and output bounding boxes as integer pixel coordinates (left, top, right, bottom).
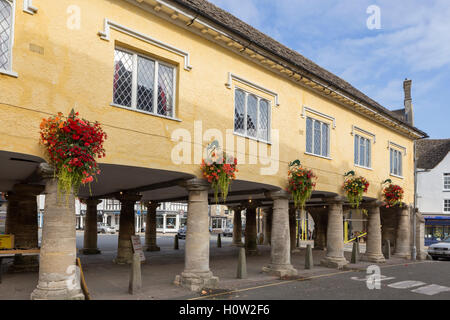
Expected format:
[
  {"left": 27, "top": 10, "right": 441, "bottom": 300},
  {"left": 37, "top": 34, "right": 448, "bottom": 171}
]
[{"left": 233, "top": 85, "right": 273, "bottom": 144}]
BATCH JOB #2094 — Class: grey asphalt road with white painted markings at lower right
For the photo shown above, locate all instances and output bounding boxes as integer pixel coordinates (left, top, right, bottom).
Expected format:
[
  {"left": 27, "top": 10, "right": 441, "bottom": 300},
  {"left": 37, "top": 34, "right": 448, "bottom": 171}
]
[{"left": 194, "top": 261, "right": 450, "bottom": 300}]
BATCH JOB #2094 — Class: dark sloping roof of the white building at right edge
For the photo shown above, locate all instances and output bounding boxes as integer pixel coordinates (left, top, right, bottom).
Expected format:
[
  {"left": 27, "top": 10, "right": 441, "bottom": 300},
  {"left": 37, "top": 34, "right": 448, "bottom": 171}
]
[{"left": 417, "top": 139, "right": 450, "bottom": 169}]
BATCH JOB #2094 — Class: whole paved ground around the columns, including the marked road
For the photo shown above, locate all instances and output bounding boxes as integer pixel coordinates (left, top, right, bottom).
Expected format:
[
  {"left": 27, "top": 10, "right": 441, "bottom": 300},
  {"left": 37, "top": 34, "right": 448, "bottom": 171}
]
[{"left": 0, "top": 232, "right": 450, "bottom": 300}]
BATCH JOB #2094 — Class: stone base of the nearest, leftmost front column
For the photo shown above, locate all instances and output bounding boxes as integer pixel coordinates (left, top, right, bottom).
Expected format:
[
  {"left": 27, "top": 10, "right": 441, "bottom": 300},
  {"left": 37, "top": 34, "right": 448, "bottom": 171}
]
[{"left": 31, "top": 280, "right": 85, "bottom": 300}]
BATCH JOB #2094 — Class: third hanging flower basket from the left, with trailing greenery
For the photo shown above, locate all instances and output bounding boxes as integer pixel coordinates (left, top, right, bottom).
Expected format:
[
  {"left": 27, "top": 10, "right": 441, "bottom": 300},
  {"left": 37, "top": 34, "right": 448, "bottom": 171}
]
[{"left": 287, "top": 160, "right": 317, "bottom": 209}]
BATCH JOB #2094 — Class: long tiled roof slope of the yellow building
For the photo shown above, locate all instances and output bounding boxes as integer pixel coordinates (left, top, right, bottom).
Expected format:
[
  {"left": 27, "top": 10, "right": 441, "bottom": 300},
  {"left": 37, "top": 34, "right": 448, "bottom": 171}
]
[{"left": 172, "top": 0, "right": 428, "bottom": 137}]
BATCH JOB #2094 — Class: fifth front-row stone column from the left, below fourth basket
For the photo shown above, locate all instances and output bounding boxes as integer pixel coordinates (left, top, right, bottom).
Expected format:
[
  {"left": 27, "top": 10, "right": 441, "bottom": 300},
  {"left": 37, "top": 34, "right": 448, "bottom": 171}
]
[{"left": 362, "top": 201, "right": 385, "bottom": 263}]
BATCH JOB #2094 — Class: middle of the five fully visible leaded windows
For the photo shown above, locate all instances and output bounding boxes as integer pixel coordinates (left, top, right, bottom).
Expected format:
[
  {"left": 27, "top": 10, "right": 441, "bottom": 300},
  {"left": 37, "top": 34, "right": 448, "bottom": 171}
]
[{"left": 306, "top": 117, "right": 330, "bottom": 157}]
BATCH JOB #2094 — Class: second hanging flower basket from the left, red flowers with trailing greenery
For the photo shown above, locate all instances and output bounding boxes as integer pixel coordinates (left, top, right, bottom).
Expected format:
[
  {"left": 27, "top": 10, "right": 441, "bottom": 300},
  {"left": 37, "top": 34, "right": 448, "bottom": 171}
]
[{"left": 200, "top": 150, "right": 238, "bottom": 203}]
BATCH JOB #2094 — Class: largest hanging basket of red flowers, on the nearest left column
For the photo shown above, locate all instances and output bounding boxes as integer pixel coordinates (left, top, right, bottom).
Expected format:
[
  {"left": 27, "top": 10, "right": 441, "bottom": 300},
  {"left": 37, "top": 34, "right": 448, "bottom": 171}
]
[{"left": 40, "top": 109, "right": 107, "bottom": 199}]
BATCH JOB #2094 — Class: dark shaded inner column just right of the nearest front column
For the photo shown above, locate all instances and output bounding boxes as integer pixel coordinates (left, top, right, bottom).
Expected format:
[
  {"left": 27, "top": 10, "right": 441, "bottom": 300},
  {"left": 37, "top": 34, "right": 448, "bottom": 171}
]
[{"left": 80, "top": 199, "right": 102, "bottom": 254}]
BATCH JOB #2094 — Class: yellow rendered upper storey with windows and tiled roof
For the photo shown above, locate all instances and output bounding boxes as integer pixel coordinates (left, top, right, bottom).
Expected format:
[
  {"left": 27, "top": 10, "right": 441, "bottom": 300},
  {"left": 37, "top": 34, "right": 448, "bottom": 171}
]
[{"left": 0, "top": 0, "right": 427, "bottom": 298}]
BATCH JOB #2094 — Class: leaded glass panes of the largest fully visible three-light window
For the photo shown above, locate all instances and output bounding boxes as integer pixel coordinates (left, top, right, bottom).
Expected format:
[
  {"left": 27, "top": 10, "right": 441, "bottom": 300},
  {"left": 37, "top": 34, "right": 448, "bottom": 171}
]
[{"left": 113, "top": 49, "right": 176, "bottom": 118}]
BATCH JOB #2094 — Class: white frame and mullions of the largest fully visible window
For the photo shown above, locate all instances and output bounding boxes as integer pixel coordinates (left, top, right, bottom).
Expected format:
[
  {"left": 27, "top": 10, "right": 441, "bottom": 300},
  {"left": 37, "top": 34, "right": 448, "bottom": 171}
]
[{"left": 110, "top": 46, "right": 181, "bottom": 121}]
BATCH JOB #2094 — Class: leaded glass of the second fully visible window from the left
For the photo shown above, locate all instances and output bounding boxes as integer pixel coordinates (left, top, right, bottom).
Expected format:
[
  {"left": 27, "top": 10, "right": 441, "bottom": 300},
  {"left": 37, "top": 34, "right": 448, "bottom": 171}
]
[{"left": 234, "top": 88, "right": 271, "bottom": 142}]
